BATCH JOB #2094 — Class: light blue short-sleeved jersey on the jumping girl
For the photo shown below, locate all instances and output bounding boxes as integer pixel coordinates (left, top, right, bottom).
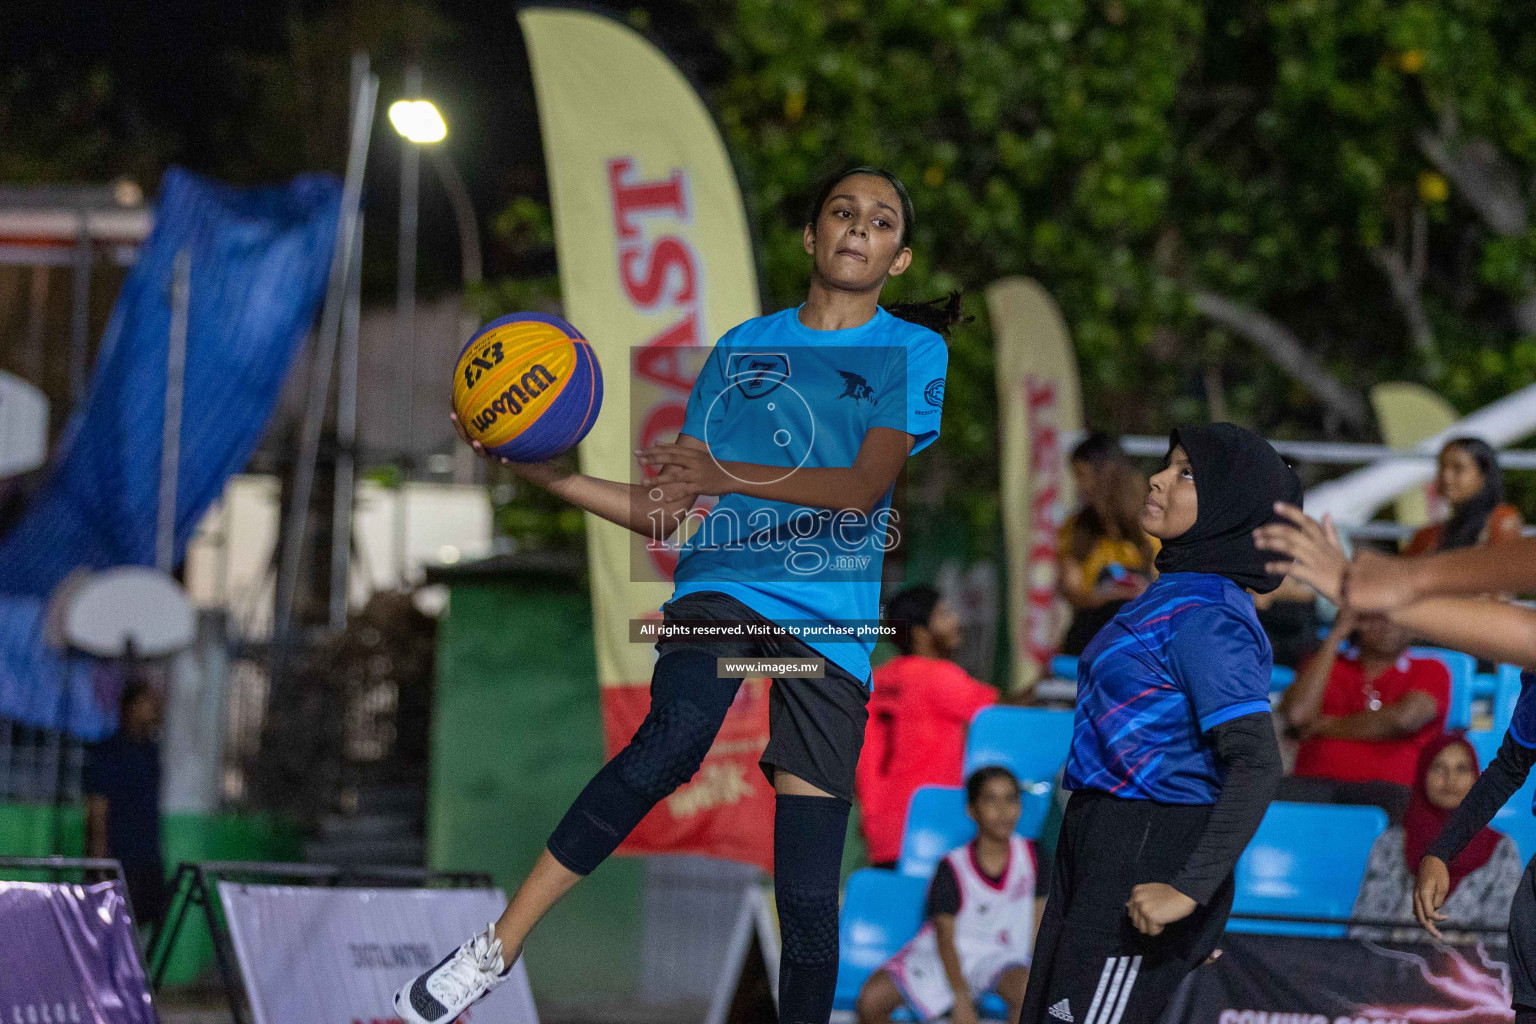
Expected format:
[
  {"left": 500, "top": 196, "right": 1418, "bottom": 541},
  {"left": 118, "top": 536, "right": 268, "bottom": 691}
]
[{"left": 674, "top": 309, "right": 949, "bottom": 685}]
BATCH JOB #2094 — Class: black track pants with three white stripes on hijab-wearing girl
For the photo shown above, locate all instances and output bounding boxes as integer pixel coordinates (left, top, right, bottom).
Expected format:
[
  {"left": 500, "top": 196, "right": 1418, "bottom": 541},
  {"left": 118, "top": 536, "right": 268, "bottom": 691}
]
[{"left": 1020, "top": 791, "right": 1232, "bottom": 1024}]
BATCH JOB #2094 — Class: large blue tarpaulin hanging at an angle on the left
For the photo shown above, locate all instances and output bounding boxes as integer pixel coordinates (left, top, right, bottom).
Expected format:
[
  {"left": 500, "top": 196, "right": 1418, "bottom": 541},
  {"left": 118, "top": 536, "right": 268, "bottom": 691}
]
[{"left": 0, "top": 169, "right": 341, "bottom": 737}]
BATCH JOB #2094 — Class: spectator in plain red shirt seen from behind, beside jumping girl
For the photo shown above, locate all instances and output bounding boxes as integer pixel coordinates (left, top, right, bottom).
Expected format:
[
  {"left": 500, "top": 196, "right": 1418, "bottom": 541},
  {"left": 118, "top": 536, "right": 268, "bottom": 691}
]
[{"left": 854, "top": 586, "right": 997, "bottom": 867}]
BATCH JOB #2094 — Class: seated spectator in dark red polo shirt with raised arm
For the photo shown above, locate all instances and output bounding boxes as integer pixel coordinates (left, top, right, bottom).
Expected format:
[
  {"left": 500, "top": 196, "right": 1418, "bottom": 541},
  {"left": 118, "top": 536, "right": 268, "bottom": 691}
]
[{"left": 1276, "top": 611, "right": 1450, "bottom": 824}]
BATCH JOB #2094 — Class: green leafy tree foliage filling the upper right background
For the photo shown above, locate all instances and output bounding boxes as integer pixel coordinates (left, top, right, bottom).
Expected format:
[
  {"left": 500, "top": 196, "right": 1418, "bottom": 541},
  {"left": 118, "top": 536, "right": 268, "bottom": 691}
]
[{"left": 696, "top": 0, "right": 1536, "bottom": 537}]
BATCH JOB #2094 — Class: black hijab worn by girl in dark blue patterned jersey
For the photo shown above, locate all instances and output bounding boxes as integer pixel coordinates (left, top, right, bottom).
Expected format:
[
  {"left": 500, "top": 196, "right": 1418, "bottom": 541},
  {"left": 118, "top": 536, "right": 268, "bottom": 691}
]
[{"left": 1157, "top": 424, "right": 1301, "bottom": 594}]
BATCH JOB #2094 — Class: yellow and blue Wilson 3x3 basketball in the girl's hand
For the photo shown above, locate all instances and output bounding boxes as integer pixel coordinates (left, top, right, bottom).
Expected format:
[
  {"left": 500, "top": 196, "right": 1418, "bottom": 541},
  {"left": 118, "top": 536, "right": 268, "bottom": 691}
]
[{"left": 453, "top": 313, "right": 602, "bottom": 462}]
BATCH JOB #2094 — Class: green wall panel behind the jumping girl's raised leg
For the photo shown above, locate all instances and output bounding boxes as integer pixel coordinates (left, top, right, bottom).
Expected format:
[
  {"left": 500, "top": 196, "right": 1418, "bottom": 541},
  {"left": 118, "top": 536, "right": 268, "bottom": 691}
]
[{"left": 427, "top": 574, "right": 642, "bottom": 1006}]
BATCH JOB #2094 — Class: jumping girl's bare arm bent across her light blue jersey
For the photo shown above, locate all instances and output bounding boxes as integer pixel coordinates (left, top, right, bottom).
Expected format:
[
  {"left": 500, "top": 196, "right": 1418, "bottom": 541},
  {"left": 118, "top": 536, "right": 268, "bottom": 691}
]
[{"left": 636, "top": 427, "right": 914, "bottom": 516}]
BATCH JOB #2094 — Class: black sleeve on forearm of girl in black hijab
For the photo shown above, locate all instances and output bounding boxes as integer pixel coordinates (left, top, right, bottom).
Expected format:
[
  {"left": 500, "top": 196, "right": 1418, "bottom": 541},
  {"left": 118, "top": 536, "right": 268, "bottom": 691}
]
[{"left": 1170, "top": 711, "right": 1281, "bottom": 904}]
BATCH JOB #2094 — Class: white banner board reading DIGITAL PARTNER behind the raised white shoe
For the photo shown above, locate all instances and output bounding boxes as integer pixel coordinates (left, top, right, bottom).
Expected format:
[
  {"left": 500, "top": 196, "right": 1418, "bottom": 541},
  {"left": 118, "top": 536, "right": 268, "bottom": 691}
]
[{"left": 218, "top": 881, "right": 539, "bottom": 1024}]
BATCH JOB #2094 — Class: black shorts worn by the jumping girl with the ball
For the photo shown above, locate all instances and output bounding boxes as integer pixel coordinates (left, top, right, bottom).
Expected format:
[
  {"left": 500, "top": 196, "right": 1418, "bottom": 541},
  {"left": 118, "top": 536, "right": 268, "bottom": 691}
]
[{"left": 656, "top": 591, "right": 869, "bottom": 803}]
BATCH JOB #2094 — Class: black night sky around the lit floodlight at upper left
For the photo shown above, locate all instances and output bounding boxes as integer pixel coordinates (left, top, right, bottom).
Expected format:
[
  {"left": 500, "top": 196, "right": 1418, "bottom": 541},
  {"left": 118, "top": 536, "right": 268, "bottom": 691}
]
[{"left": 0, "top": 0, "right": 723, "bottom": 301}]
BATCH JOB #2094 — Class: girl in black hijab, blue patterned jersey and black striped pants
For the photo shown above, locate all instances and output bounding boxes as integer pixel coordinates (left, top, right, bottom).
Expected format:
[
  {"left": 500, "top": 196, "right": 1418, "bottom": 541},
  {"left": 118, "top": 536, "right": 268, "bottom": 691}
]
[{"left": 1020, "top": 424, "right": 1301, "bottom": 1024}]
